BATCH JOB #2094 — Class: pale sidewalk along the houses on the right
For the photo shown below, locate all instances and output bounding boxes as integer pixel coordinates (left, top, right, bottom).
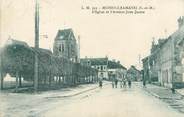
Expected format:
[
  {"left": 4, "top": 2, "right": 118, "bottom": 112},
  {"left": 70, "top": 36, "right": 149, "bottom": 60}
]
[{"left": 145, "top": 84, "right": 182, "bottom": 100}]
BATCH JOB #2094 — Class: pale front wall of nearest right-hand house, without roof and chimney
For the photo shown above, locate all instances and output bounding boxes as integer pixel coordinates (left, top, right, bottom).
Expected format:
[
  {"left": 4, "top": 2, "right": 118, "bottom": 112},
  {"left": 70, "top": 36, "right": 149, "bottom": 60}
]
[{"left": 159, "top": 38, "right": 184, "bottom": 88}]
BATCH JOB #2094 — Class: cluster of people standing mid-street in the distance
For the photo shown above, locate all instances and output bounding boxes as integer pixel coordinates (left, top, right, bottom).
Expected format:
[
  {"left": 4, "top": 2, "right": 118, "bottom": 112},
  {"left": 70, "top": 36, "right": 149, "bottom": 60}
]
[{"left": 112, "top": 78, "right": 132, "bottom": 88}]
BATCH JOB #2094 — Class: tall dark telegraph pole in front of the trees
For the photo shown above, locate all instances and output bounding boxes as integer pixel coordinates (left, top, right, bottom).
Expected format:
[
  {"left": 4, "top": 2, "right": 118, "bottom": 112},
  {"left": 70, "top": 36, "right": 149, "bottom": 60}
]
[{"left": 34, "top": 0, "right": 39, "bottom": 92}]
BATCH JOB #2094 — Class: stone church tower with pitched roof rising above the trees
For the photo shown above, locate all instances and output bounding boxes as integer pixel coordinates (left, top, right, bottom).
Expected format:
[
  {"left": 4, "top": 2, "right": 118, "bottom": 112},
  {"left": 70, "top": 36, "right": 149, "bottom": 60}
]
[{"left": 53, "top": 29, "right": 80, "bottom": 63}]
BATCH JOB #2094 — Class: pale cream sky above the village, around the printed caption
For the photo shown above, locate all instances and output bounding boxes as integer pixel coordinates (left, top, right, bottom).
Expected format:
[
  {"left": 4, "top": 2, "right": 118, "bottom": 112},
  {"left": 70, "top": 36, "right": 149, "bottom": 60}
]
[{"left": 0, "top": 0, "right": 184, "bottom": 67}]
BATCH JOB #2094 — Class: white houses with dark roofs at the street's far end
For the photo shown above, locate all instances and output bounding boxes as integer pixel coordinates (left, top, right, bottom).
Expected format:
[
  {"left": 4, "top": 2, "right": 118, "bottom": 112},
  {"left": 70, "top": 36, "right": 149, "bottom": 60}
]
[{"left": 80, "top": 57, "right": 127, "bottom": 80}]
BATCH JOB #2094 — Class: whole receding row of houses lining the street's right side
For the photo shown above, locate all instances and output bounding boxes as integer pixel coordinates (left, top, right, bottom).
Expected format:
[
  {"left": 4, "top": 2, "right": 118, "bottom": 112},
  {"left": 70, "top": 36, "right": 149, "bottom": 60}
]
[{"left": 143, "top": 17, "right": 184, "bottom": 88}]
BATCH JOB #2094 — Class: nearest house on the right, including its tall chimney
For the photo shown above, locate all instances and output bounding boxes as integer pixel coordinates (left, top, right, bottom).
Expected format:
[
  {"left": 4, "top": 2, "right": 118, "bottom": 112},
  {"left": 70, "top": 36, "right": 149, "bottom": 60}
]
[{"left": 159, "top": 17, "right": 184, "bottom": 88}]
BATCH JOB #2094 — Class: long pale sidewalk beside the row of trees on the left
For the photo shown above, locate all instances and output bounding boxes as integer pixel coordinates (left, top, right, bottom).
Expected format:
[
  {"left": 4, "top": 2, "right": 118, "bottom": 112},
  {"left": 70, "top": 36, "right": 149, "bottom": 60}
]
[{"left": 0, "top": 81, "right": 110, "bottom": 99}]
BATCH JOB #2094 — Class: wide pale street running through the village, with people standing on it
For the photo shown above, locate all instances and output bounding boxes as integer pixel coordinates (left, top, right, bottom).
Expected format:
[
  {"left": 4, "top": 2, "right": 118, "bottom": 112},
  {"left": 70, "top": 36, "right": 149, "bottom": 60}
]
[{"left": 0, "top": 83, "right": 183, "bottom": 117}]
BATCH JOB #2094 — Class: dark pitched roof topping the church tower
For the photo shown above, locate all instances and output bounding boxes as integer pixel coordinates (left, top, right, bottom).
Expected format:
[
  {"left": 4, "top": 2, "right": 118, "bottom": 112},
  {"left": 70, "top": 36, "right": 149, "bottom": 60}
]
[{"left": 55, "top": 28, "right": 74, "bottom": 40}]
